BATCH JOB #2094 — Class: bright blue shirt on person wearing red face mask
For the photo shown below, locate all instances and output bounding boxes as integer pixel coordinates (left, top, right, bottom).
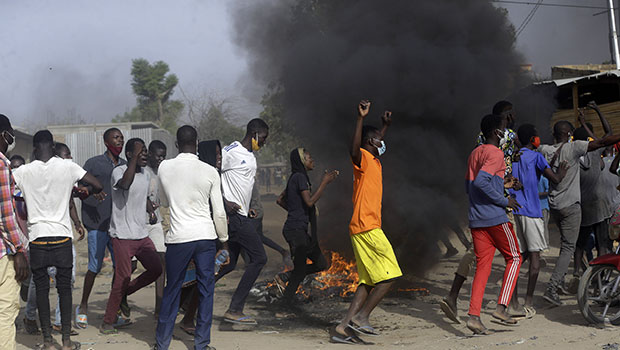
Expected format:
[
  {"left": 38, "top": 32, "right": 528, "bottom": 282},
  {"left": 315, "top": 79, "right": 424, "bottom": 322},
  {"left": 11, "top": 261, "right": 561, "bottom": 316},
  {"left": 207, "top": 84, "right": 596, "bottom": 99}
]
[{"left": 510, "top": 147, "right": 549, "bottom": 218}]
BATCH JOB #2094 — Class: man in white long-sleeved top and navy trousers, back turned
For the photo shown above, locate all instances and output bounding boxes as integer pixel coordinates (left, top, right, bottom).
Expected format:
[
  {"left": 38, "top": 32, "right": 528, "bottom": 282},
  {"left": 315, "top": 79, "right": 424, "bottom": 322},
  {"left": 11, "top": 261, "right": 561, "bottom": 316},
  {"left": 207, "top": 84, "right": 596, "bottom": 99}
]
[{"left": 156, "top": 125, "right": 228, "bottom": 350}]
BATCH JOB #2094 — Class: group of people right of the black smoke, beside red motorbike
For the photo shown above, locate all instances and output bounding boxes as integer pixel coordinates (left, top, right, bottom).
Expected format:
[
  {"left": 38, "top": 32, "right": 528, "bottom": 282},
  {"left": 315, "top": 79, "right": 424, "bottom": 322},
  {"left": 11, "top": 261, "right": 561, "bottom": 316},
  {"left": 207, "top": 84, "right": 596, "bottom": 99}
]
[{"left": 440, "top": 101, "right": 620, "bottom": 335}]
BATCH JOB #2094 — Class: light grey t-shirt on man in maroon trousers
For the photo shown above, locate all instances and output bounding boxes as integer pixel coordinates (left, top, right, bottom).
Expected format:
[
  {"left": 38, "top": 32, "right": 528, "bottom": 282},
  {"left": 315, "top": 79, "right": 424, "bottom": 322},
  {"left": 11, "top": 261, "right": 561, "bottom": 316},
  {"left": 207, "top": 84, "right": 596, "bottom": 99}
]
[{"left": 110, "top": 165, "right": 151, "bottom": 239}]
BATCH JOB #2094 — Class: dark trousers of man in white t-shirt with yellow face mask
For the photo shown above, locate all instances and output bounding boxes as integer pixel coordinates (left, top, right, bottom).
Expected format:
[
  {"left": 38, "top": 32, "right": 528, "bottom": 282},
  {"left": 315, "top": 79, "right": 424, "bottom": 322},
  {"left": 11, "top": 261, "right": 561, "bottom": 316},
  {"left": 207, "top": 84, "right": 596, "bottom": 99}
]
[{"left": 215, "top": 214, "right": 267, "bottom": 312}]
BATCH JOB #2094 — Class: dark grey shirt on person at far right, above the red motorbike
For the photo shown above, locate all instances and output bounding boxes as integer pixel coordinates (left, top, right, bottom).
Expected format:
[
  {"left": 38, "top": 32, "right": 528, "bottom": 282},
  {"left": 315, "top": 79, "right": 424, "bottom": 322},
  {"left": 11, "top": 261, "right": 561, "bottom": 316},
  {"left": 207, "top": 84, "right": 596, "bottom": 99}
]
[{"left": 579, "top": 148, "right": 611, "bottom": 226}]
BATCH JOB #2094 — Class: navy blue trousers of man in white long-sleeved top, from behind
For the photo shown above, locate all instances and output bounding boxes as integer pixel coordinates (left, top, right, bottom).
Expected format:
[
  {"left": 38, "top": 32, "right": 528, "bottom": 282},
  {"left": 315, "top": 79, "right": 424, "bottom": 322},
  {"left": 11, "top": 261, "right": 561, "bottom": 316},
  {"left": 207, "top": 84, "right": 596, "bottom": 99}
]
[{"left": 155, "top": 240, "right": 216, "bottom": 350}]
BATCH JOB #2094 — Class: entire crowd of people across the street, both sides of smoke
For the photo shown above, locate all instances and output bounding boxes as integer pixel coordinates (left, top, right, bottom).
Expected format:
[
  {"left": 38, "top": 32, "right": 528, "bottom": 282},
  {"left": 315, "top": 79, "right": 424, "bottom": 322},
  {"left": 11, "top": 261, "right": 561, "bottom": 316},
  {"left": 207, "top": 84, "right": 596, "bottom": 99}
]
[{"left": 0, "top": 100, "right": 620, "bottom": 350}]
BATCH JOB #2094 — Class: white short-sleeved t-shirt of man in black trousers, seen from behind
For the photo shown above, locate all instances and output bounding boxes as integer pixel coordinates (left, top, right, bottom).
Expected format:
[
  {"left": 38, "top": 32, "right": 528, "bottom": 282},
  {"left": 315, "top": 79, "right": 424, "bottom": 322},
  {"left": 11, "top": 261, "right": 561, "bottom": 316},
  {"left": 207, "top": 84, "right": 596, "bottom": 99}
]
[{"left": 13, "top": 157, "right": 86, "bottom": 242}]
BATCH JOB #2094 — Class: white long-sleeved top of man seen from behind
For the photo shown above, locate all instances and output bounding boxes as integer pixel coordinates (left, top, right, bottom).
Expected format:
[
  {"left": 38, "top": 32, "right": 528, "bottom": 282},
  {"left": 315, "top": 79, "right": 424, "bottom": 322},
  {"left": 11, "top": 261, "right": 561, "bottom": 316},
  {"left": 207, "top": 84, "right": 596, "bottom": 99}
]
[{"left": 157, "top": 153, "right": 228, "bottom": 244}]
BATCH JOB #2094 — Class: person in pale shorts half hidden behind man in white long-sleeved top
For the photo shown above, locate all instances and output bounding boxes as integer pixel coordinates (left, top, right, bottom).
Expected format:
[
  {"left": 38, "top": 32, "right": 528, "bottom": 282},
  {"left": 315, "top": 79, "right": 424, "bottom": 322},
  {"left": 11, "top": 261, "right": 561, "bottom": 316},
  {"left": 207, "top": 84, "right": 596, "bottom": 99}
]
[{"left": 144, "top": 140, "right": 166, "bottom": 317}]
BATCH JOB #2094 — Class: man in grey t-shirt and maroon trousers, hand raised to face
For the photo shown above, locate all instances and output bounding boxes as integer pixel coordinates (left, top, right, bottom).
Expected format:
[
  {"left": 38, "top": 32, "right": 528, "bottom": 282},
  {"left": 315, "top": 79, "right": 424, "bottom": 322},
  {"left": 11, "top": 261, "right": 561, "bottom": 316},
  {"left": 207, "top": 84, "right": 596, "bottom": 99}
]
[{"left": 99, "top": 138, "right": 162, "bottom": 334}]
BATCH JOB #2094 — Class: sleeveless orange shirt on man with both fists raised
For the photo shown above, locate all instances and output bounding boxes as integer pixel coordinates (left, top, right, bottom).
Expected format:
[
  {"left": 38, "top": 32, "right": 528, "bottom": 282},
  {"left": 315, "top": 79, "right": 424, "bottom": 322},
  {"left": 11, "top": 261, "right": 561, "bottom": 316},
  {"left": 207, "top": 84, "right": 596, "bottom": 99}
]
[{"left": 349, "top": 148, "right": 383, "bottom": 235}]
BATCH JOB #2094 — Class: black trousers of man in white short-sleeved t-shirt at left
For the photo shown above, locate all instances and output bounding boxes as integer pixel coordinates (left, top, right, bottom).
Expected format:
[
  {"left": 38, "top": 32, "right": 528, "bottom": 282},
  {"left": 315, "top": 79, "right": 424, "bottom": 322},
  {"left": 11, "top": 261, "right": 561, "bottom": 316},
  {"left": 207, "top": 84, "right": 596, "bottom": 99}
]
[{"left": 30, "top": 237, "right": 73, "bottom": 341}]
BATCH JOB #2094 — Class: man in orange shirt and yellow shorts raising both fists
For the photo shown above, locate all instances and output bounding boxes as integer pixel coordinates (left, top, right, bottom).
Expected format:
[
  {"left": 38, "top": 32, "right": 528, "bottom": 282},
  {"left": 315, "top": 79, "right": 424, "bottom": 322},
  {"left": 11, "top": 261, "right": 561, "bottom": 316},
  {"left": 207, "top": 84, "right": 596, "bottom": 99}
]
[{"left": 331, "top": 100, "right": 402, "bottom": 344}]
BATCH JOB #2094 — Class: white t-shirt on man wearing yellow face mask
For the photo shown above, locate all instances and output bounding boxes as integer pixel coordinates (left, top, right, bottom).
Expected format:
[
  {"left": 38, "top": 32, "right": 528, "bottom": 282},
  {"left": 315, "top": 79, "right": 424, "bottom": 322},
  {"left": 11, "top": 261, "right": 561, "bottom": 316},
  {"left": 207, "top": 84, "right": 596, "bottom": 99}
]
[{"left": 222, "top": 141, "right": 256, "bottom": 216}]
